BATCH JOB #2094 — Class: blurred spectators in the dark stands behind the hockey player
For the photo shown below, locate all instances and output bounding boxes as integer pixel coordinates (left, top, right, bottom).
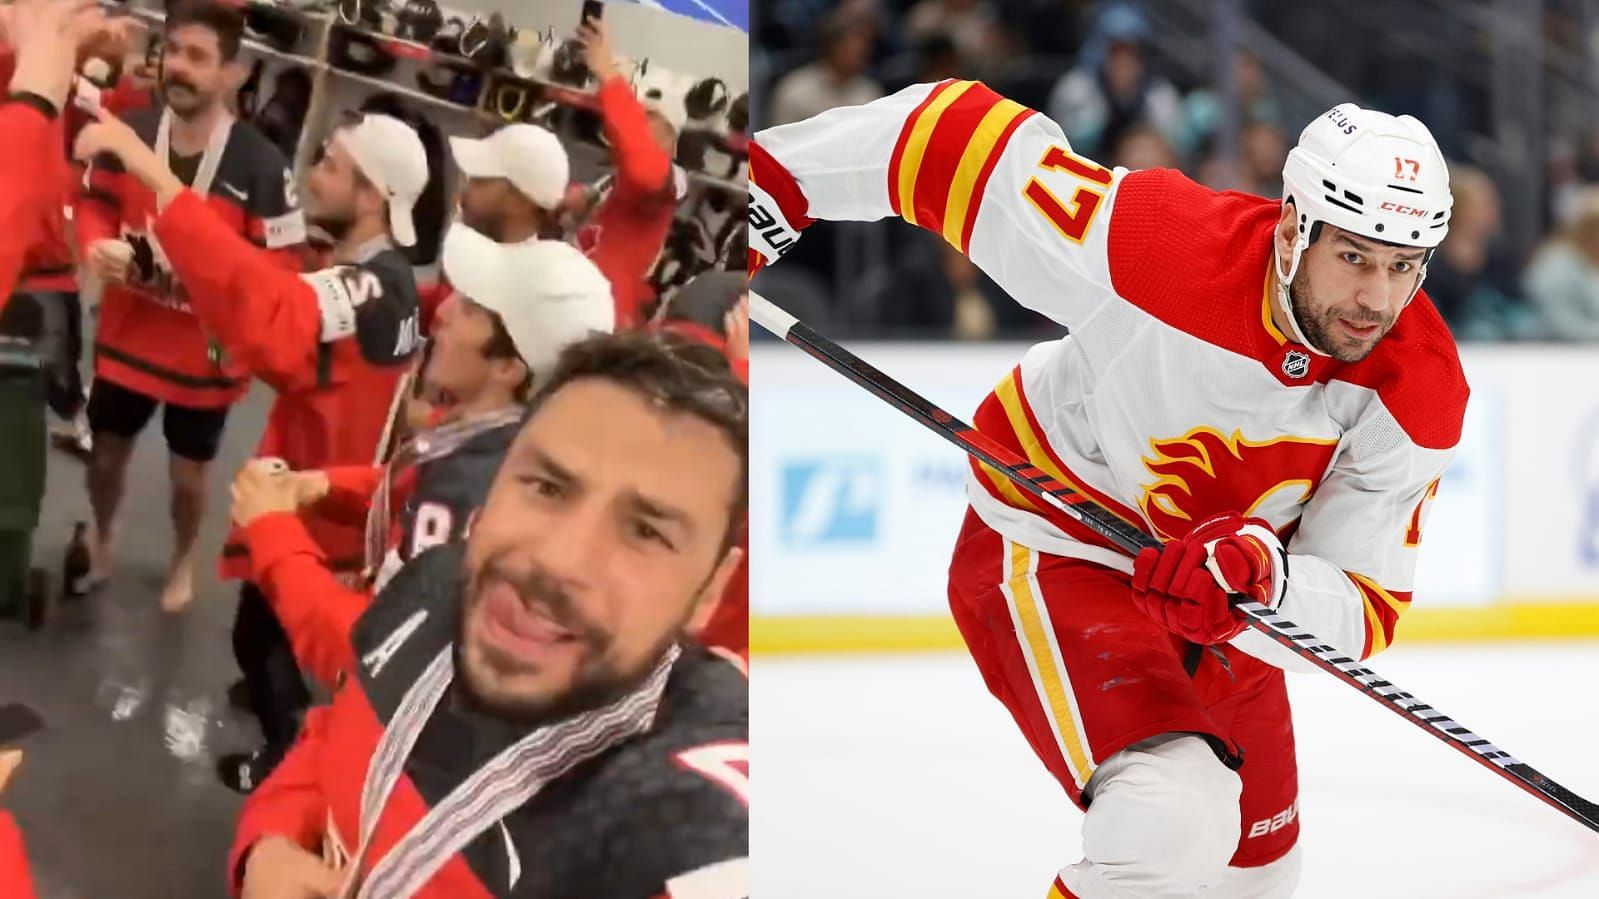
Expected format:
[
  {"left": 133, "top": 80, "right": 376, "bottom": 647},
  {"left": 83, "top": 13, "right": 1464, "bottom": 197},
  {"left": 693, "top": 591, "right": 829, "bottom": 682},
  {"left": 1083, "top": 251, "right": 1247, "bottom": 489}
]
[{"left": 750, "top": 0, "right": 1599, "bottom": 341}]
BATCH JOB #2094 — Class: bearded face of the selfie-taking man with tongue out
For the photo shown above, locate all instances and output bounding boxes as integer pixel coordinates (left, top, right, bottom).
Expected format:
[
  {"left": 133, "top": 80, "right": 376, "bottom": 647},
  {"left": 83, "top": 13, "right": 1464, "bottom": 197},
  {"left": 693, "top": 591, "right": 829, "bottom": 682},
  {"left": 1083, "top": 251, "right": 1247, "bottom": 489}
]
[{"left": 456, "top": 379, "right": 740, "bottom": 725}]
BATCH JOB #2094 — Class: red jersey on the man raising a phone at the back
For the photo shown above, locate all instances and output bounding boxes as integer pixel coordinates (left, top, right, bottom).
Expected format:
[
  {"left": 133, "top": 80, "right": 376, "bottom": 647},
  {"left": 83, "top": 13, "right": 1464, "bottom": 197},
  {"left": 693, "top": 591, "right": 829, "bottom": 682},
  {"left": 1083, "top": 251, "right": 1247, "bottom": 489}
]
[{"left": 577, "top": 77, "right": 676, "bottom": 331}]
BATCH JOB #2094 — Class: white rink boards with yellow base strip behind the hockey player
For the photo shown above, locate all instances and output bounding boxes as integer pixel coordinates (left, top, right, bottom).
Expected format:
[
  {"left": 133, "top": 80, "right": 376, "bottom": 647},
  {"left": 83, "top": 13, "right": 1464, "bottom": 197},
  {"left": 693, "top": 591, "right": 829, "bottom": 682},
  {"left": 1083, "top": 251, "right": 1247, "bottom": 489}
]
[{"left": 750, "top": 344, "right": 1599, "bottom": 653}]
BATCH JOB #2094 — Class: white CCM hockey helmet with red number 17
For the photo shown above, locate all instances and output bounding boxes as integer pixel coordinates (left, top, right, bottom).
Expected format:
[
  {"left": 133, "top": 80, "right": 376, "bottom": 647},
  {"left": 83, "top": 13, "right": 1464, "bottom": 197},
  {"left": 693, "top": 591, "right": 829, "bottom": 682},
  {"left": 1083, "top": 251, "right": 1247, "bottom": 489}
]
[{"left": 1273, "top": 102, "right": 1453, "bottom": 355}]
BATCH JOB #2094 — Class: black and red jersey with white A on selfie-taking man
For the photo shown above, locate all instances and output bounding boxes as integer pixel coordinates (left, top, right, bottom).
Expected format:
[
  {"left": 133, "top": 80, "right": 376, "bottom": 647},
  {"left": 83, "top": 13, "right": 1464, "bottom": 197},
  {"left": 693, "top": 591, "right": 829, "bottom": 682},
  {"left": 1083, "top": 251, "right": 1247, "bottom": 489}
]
[{"left": 232, "top": 544, "right": 748, "bottom": 899}]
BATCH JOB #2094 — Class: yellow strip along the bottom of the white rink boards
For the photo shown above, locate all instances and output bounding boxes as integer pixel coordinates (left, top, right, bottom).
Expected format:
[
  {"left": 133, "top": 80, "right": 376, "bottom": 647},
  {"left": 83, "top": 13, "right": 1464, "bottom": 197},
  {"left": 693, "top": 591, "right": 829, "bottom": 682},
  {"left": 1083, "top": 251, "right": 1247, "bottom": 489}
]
[{"left": 750, "top": 601, "right": 1599, "bottom": 656}]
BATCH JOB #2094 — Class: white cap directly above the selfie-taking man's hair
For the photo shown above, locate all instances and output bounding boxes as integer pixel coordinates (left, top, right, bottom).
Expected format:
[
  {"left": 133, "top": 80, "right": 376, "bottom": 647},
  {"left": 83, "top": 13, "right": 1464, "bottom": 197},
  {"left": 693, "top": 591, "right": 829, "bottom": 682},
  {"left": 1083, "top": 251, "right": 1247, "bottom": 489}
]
[{"left": 443, "top": 222, "right": 616, "bottom": 382}]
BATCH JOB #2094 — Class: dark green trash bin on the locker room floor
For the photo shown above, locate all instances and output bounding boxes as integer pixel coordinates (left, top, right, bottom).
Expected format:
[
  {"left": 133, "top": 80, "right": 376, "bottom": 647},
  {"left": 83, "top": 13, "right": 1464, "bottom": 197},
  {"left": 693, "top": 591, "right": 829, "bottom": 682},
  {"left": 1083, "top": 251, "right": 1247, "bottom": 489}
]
[{"left": 0, "top": 338, "right": 48, "bottom": 627}]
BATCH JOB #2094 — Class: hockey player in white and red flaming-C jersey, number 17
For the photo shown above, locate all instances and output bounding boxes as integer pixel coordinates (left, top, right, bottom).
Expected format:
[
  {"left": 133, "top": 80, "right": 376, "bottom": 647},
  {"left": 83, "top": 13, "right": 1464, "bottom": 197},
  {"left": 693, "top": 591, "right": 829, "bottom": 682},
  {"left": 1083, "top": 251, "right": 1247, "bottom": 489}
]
[{"left": 750, "top": 80, "right": 1468, "bottom": 899}]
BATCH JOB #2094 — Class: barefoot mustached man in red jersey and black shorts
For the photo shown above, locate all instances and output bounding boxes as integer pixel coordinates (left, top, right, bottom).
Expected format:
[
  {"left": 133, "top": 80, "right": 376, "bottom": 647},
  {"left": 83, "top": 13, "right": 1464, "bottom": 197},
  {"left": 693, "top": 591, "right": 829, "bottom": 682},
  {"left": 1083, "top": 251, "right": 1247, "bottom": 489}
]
[{"left": 74, "top": 0, "right": 305, "bottom": 613}]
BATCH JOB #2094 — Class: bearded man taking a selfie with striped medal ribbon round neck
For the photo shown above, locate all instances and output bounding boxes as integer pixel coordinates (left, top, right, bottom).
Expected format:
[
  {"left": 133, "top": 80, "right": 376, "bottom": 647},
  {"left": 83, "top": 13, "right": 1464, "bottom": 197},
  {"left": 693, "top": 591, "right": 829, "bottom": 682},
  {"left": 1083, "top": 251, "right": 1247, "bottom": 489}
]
[{"left": 229, "top": 334, "right": 748, "bottom": 899}]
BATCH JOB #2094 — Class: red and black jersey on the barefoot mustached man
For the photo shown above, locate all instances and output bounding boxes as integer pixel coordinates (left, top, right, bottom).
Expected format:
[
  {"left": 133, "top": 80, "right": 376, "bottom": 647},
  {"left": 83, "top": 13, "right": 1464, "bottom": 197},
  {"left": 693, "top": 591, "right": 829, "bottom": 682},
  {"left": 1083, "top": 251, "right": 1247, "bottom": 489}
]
[{"left": 74, "top": 109, "right": 305, "bottom": 408}]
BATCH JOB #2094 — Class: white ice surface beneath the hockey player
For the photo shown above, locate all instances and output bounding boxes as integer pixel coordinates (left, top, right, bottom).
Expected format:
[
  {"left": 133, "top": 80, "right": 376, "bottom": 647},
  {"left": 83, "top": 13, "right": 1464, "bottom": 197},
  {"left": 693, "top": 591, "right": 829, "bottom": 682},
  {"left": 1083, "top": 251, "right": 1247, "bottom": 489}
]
[{"left": 750, "top": 641, "right": 1599, "bottom": 899}]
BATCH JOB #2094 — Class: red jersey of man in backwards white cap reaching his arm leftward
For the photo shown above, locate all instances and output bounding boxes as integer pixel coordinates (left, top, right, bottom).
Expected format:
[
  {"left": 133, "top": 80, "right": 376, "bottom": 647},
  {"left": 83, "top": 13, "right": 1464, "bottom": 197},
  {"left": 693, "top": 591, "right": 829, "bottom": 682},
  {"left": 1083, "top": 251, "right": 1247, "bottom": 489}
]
[{"left": 154, "top": 190, "right": 419, "bottom": 577}]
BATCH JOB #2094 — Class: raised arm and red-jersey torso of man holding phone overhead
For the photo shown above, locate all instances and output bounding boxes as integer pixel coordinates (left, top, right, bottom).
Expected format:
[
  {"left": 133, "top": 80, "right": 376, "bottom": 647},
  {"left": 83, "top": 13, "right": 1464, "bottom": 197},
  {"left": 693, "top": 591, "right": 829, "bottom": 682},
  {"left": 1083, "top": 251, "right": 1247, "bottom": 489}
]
[{"left": 569, "top": 19, "right": 683, "bottom": 328}]
